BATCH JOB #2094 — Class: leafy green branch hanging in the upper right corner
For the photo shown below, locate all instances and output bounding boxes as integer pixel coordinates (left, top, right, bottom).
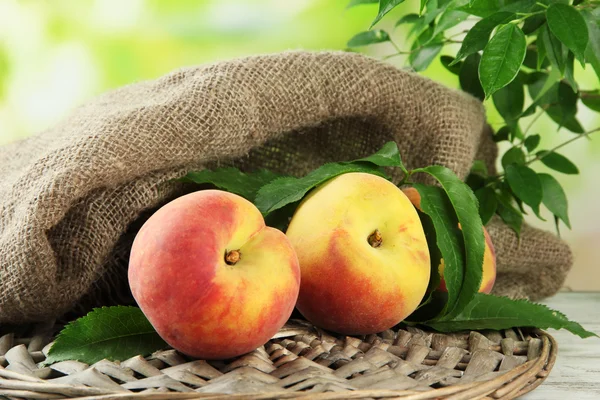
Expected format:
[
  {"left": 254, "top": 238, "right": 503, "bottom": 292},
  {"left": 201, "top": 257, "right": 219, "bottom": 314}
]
[{"left": 344, "top": 0, "right": 600, "bottom": 238}]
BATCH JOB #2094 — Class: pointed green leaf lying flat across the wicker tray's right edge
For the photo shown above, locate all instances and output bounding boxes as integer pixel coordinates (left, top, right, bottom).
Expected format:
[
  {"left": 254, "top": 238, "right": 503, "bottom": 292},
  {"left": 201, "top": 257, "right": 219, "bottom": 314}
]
[{"left": 426, "top": 293, "right": 597, "bottom": 338}]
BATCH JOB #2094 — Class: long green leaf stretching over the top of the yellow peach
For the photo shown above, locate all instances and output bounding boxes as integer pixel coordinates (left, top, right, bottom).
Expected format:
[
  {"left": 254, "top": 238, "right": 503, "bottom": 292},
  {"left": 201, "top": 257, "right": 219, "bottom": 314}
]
[{"left": 254, "top": 142, "right": 406, "bottom": 217}]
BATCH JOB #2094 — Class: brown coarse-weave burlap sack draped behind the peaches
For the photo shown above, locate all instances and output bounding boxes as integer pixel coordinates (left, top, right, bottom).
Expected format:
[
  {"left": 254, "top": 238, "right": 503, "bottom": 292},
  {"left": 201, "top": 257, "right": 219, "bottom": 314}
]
[{"left": 0, "top": 52, "right": 571, "bottom": 323}]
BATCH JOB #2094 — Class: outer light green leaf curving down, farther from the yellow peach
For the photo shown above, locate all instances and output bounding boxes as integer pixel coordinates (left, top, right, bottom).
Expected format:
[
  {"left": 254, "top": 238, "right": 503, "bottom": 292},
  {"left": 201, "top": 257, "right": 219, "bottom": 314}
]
[{"left": 414, "top": 165, "right": 484, "bottom": 318}]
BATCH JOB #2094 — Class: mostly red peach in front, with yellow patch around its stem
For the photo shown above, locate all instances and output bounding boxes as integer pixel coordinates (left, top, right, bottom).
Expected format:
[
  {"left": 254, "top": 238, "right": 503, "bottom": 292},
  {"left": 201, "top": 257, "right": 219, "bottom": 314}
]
[{"left": 129, "top": 190, "right": 300, "bottom": 359}]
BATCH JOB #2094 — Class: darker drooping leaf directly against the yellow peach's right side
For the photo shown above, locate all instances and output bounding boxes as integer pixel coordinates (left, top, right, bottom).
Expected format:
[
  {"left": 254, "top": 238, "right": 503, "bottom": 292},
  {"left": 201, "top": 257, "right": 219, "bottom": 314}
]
[{"left": 414, "top": 183, "right": 465, "bottom": 313}]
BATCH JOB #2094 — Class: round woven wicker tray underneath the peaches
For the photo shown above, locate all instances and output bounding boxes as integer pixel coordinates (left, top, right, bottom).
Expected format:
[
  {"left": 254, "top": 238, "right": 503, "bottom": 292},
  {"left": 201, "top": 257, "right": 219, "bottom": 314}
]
[{"left": 0, "top": 320, "right": 557, "bottom": 400}]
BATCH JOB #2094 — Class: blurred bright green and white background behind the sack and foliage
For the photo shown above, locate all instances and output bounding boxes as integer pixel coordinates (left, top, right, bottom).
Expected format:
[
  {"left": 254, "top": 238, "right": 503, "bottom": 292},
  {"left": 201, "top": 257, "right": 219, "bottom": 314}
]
[{"left": 0, "top": 0, "right": 600, "bottom": 290}]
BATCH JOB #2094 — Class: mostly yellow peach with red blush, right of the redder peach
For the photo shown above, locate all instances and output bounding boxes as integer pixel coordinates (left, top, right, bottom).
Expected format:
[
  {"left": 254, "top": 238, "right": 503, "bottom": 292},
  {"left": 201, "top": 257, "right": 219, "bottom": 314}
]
[{"left": 286, "top": 173, "right": 431, "bottom": 334}]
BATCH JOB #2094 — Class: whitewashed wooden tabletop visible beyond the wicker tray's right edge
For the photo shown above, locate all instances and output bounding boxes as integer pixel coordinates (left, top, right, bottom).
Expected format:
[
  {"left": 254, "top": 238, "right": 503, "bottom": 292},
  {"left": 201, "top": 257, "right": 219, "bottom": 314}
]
[{"left": 521, "top": 292, "right": 600, "bottom": 400}]
